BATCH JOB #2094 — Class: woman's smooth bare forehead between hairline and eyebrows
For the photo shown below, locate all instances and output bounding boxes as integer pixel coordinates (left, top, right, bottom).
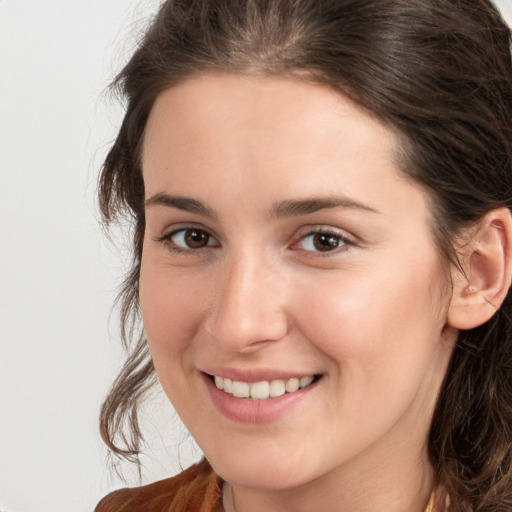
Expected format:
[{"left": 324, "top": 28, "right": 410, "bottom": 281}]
[{"left": 142, "top": 75, "right": 422, "bottom": 222}]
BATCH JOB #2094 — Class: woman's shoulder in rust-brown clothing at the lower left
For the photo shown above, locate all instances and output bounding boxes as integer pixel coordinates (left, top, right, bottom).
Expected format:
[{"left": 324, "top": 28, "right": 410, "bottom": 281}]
[{"left": 94, "top": 459, "right": 222, "bottom": 512}]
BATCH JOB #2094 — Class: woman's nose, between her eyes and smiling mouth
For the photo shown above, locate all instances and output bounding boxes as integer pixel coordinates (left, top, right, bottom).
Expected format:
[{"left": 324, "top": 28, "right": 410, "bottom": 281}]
[{"left": 208, "top": 251, "right": 288, "bottom": 353}]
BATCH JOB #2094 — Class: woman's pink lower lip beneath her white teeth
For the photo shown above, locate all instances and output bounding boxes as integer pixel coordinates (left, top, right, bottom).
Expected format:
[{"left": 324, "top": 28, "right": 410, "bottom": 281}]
[{"left": 203, "top": 374, "right": 318, "bottom": 425}]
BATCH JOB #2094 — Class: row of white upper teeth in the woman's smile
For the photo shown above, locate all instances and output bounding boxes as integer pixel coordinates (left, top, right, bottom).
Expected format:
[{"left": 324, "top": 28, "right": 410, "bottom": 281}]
[{"left": 214, "top": 375, "right": 314, "bottom": 400}]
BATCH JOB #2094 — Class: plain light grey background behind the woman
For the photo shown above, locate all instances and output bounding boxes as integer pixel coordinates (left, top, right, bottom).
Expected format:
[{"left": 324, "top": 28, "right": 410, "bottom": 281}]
[{"left": 0, "top": 0, "right": 512, "bottom": 512}]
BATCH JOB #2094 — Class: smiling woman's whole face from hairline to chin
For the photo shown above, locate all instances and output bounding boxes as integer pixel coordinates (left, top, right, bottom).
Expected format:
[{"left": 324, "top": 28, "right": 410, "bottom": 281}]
[{"left": 140, "top": 75, "right": 453, "bottom": 489}]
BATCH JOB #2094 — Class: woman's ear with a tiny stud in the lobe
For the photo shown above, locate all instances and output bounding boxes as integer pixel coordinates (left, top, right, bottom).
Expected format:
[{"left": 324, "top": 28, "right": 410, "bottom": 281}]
[{"left": 447, "top": 208, "right": 512, "bottom": 329}]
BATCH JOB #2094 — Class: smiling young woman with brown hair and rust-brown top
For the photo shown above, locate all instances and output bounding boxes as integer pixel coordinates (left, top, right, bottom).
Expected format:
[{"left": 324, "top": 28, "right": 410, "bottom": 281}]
[{"left": 97, "top": 0, "right": 512, "bottom": 512}]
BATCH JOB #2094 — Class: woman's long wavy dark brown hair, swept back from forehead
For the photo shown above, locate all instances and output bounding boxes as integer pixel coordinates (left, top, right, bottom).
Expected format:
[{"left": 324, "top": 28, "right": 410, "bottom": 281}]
[{"left": 99, "top": 0, "right": 512, "bottom": 512}]
